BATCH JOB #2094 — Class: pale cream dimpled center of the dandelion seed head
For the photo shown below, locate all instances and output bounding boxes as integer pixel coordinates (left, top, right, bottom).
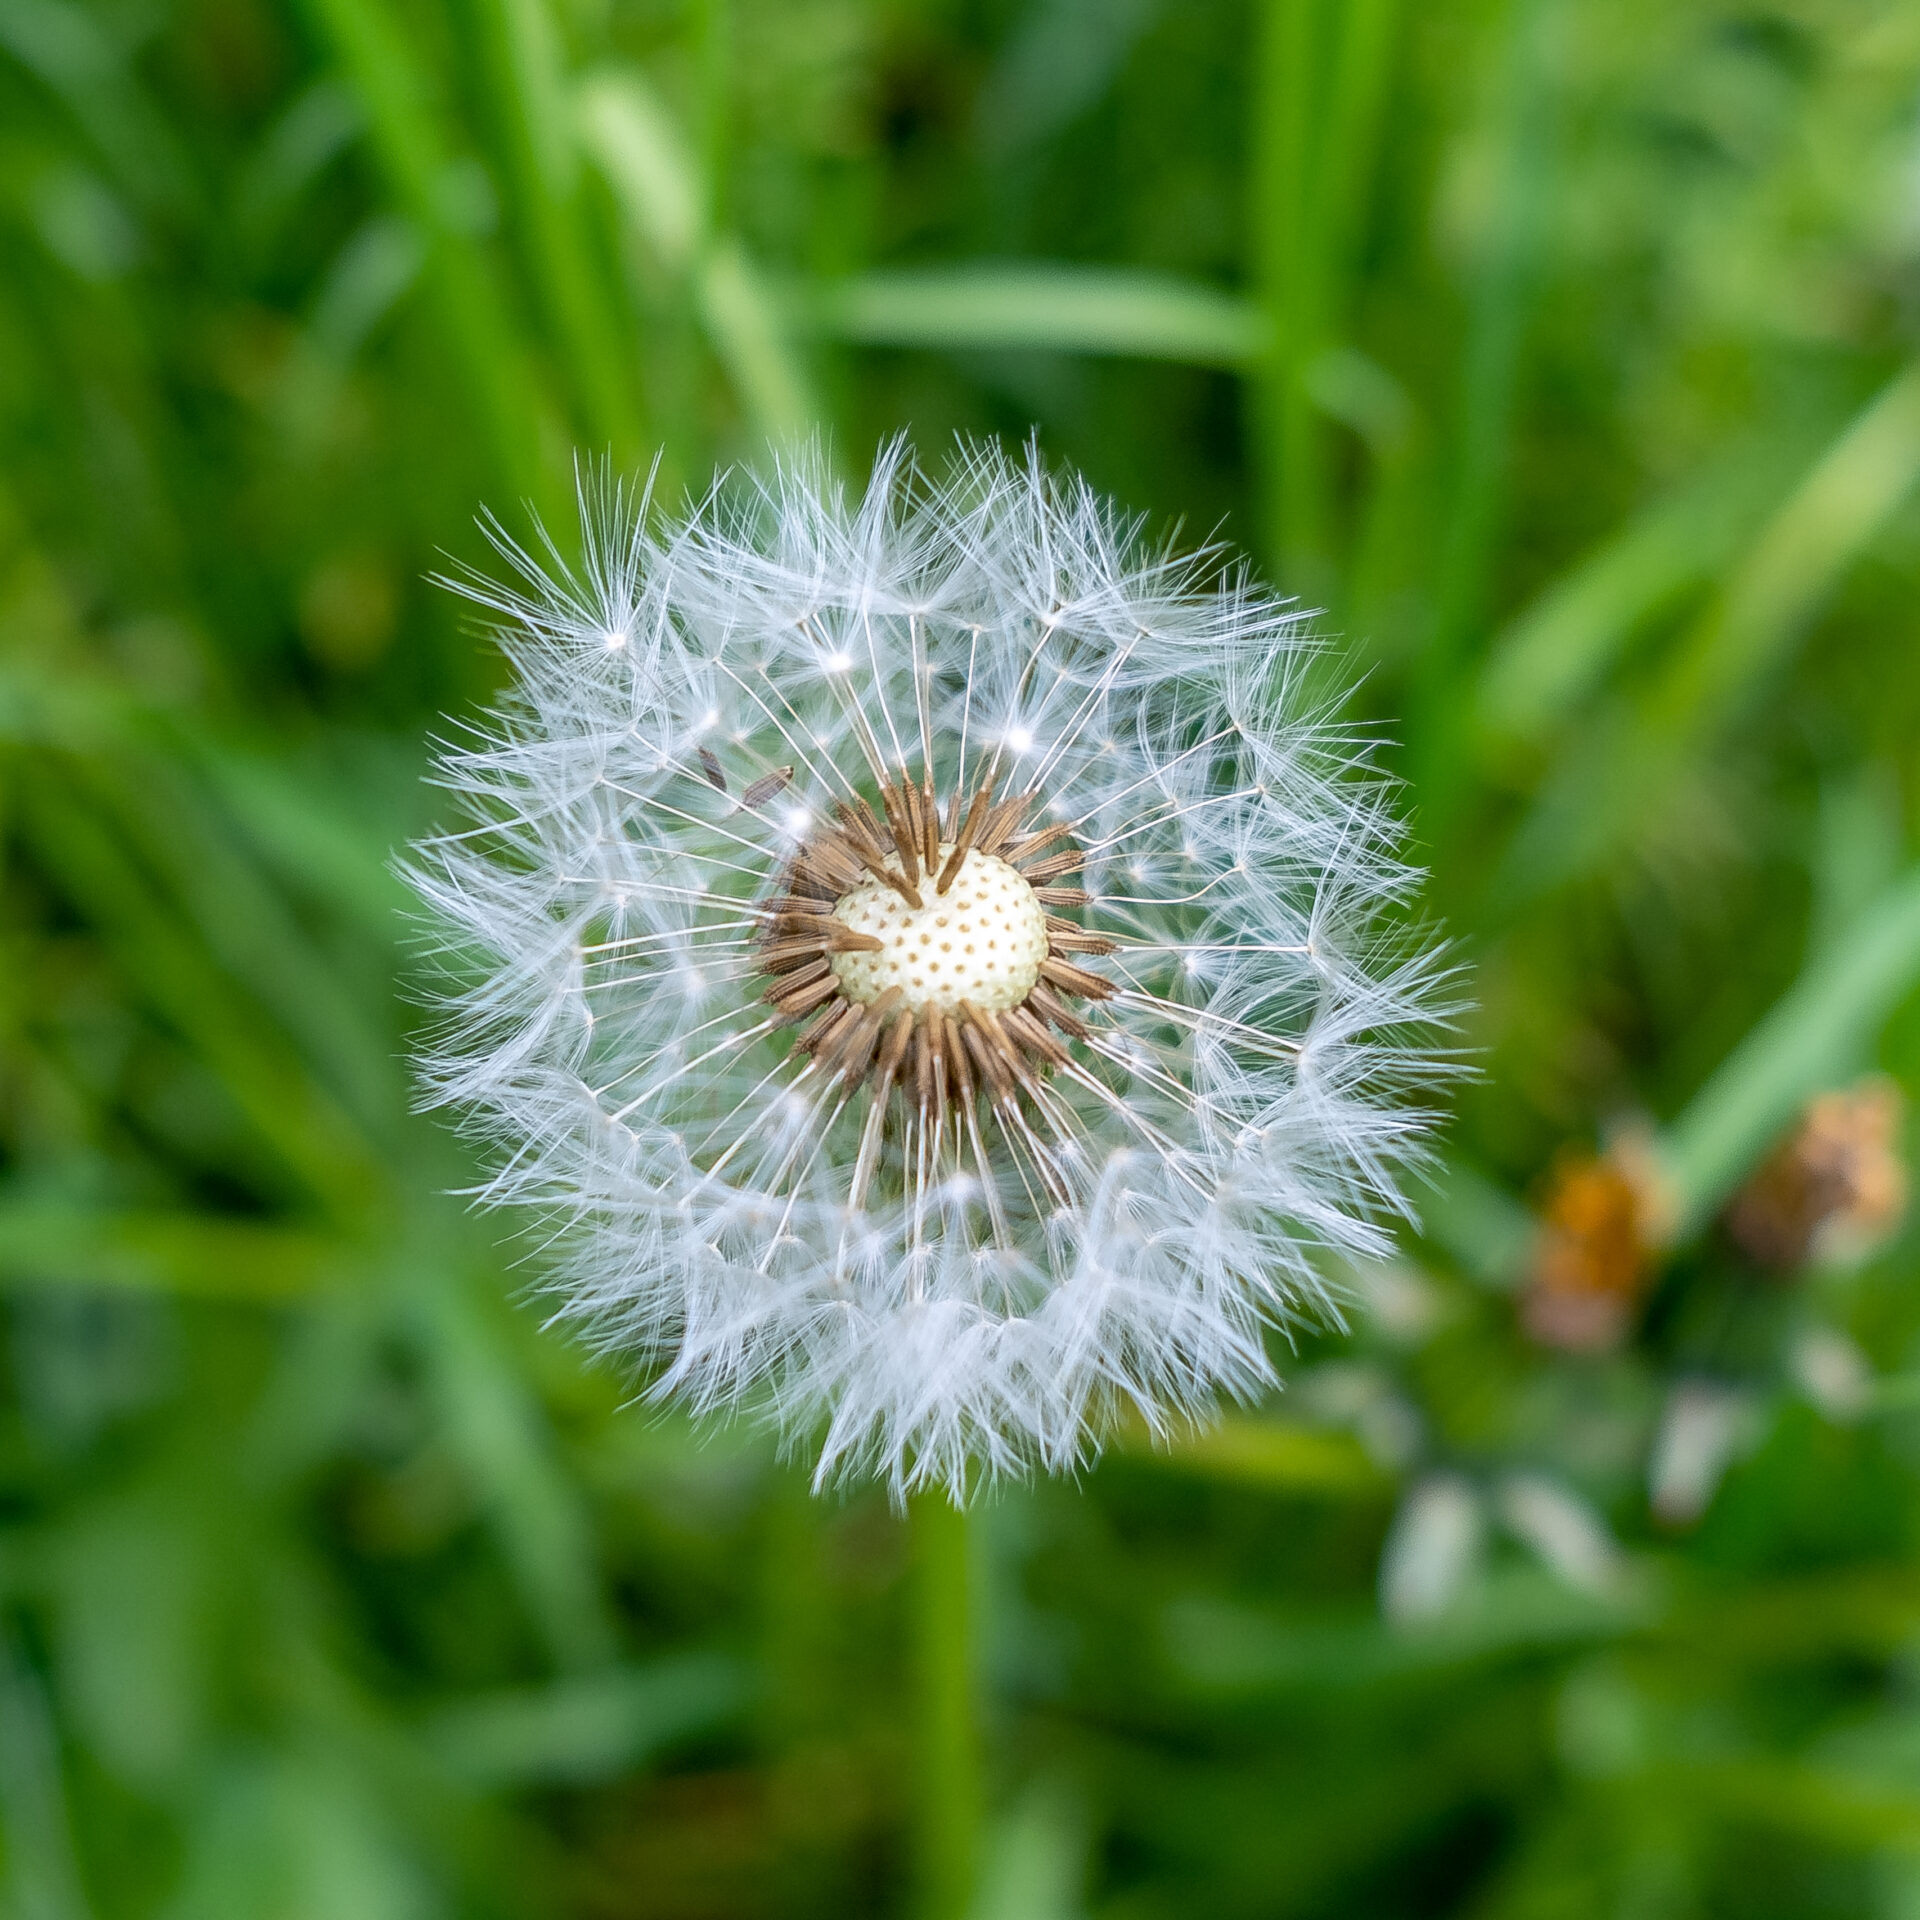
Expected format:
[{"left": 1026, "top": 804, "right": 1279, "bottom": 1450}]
[{"left": 831, "top": 845, "right": 1046, "bottom": 1014}]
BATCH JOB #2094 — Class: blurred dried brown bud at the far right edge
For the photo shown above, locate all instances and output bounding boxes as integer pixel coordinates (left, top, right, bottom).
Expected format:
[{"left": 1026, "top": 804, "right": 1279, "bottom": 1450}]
[{"left": 1726, "top": 1075, "right": 1907, "bottom": 1273}]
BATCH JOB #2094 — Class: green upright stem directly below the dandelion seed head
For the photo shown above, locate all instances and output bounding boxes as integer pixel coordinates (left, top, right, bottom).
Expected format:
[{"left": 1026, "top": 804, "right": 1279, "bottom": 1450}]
[{"left": 912, "top": 1492, "right": 981, "bottom": 1920}]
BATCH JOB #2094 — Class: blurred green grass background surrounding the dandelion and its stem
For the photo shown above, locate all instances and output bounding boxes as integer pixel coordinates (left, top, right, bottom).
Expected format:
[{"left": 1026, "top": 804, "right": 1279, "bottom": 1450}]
[{"left": 11, "top": 0, "right": 1920, "bottom": 1920}]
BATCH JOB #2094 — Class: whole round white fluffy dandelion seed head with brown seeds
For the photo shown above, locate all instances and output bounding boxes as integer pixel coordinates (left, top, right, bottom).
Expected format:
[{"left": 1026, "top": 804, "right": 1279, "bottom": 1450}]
[{"left": 411, "top": 447, "right": 1446, "bottom": 1498}]
